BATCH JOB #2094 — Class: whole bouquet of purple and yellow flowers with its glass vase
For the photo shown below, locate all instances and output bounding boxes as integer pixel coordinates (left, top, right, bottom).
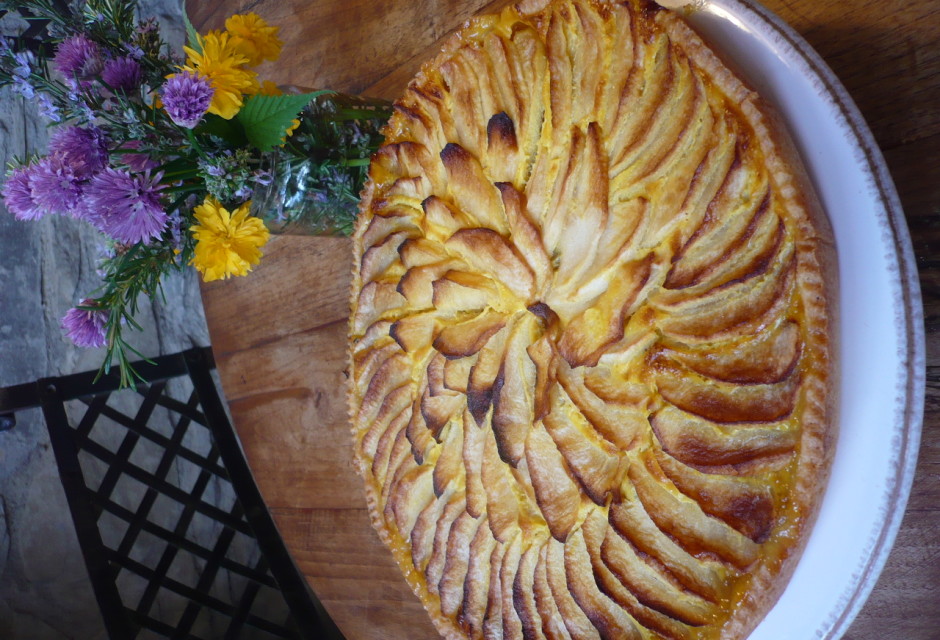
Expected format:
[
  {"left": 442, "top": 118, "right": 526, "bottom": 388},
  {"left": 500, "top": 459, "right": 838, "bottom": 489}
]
[{"left": 0, "top": 0, "right": 391, "bottom": 385}]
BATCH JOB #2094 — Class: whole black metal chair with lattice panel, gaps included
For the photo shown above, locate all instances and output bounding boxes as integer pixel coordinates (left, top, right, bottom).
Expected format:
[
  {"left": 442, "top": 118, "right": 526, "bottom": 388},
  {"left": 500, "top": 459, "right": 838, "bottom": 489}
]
[{"left": 0, "top": 348, "right": 342, "bottom": 640}]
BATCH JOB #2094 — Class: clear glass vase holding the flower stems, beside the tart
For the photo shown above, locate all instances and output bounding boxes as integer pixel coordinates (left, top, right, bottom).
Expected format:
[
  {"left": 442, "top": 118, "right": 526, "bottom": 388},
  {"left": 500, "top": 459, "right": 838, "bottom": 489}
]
[{"left": 251, "top": 92, "right": 392, "bottom": 235}]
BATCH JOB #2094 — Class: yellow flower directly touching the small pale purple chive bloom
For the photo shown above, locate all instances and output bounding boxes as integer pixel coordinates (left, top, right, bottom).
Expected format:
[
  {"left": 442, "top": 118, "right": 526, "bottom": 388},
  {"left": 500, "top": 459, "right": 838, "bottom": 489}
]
[{"left": 182, "top": 31, "right": 258, "bottom": 120}]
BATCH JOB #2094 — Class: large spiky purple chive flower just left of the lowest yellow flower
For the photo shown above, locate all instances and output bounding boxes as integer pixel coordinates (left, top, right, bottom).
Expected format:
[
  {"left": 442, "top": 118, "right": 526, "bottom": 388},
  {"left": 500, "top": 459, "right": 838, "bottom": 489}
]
[{"left": 83, "top": 168, "right": 167, "bottom": 244}]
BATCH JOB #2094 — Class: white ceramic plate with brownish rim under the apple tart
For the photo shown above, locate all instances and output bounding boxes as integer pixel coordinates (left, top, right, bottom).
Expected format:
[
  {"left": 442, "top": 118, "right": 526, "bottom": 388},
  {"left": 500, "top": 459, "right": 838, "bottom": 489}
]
[{"left": 676, "top": 0, "right": 925, "bottom": 640}]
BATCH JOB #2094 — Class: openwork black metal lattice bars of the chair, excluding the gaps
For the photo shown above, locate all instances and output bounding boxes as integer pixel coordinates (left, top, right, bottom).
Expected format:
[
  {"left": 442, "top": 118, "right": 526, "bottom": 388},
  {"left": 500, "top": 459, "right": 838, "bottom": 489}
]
[{"left": 0, "top": 348, "right": 342, "bottom": 640}]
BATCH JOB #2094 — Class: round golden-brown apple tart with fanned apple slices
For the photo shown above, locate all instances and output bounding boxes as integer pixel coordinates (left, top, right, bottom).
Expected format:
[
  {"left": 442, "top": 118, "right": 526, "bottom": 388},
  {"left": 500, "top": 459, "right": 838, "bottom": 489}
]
[{"left": 349, "top": 0, "right": 834, "bottom": 640}]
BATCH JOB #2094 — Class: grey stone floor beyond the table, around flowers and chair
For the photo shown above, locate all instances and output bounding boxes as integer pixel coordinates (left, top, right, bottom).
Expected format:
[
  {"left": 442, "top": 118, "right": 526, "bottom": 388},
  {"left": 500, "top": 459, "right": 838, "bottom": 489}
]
[{"left": 0, "top": 0, "right": 217, "bottom": 640}]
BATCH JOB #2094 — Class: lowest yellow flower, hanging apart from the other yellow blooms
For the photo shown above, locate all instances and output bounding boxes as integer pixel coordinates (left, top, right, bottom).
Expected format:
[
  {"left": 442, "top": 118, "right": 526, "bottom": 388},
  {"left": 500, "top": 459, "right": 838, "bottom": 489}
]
[{"left": 190, "top": 196, "right": 270, "bottom": 282}]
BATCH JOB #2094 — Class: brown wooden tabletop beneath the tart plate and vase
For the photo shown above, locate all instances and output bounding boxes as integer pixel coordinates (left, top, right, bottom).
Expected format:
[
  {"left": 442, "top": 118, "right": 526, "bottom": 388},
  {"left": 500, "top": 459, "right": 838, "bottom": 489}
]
[{"left": 190, "top": 0, "right": 940, "bottom": 640}]
